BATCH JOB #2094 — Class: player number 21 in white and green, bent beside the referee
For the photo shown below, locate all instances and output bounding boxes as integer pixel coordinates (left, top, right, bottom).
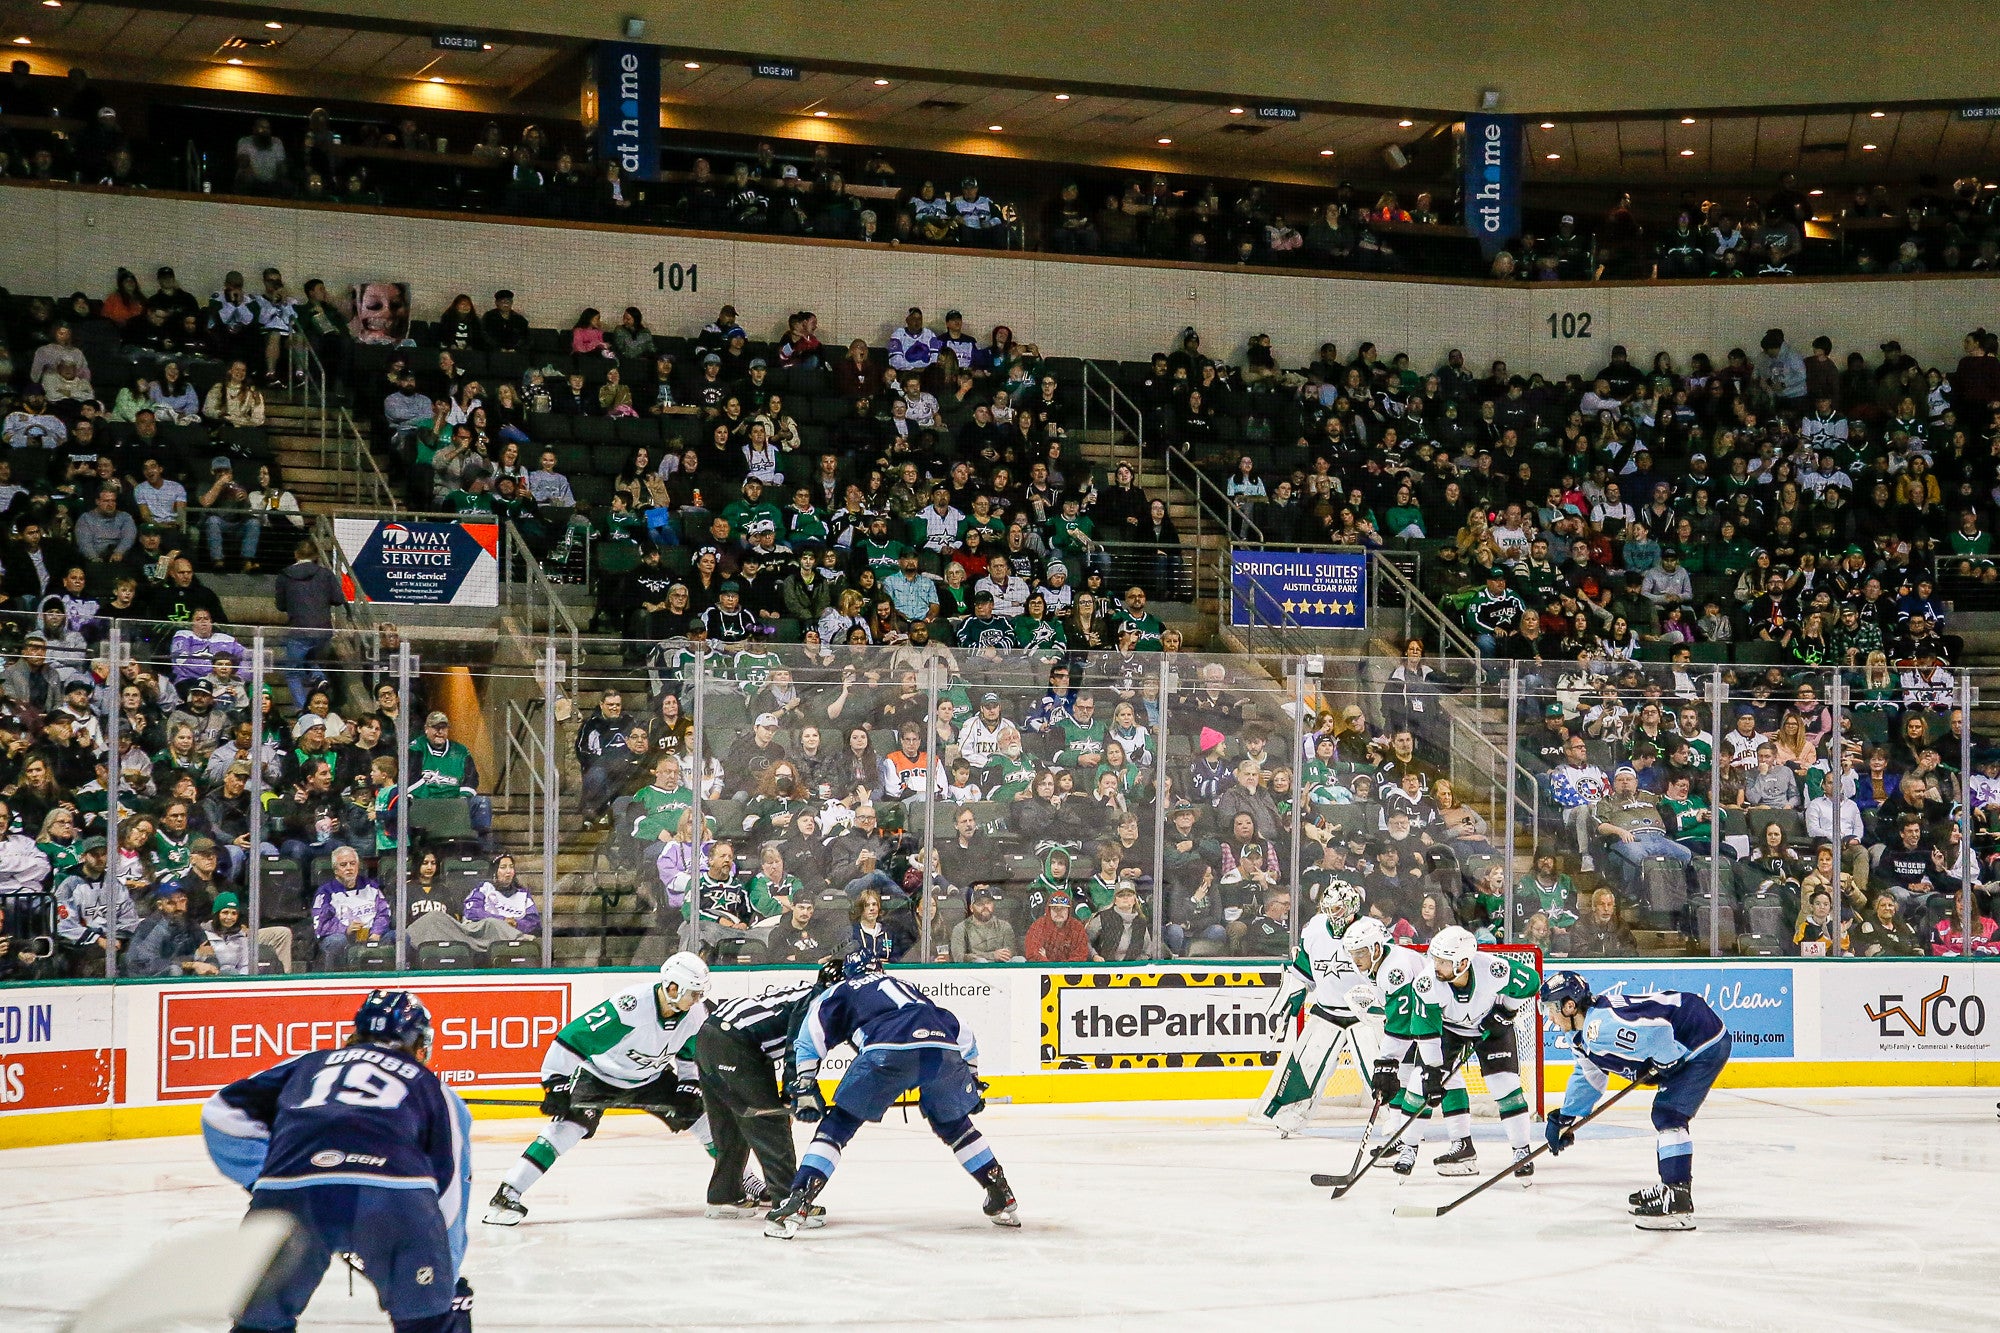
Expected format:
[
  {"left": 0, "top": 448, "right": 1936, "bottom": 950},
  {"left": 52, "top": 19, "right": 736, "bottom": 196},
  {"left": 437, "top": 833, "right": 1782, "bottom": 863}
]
[{"left": 484, "top": 953, "right": 728, "bottom": 1227}]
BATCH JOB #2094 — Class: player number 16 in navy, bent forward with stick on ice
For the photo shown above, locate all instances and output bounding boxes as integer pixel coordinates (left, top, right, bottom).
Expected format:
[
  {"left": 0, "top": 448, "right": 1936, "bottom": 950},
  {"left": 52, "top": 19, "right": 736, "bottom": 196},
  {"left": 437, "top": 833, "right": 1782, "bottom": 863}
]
[{"left": 1542, "top": 973, "right": 1730, "bottom": 1231}]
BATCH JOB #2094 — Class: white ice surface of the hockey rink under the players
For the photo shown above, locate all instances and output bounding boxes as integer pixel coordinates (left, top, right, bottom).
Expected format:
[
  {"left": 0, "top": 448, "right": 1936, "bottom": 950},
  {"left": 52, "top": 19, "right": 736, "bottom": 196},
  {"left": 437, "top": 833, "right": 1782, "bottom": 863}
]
[{"left": 0, "top": 1089, "right": 2000, "bottom": 1333}]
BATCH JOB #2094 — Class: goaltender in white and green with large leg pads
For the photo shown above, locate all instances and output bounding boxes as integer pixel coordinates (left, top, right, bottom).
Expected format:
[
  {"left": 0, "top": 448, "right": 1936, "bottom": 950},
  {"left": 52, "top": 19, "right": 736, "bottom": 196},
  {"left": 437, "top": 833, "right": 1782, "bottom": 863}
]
[{"left": 1250, "top": 879, "right": 1382, "bottom": 1139}]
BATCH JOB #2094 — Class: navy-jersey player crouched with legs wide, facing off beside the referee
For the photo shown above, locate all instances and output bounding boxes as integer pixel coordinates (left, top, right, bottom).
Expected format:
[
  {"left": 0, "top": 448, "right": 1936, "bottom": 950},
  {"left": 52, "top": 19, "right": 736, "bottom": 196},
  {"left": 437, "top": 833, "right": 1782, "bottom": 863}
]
[{"left": 764, "top": 953, "right": 1020, "bottom": 1241}]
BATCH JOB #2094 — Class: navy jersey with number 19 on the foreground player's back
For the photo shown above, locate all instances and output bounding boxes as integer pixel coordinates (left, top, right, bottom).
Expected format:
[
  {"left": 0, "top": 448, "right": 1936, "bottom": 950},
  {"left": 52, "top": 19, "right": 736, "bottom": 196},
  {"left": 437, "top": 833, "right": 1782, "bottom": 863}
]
[{"left": 202, "top": 1045, "right": 472, "bottom": 1255}]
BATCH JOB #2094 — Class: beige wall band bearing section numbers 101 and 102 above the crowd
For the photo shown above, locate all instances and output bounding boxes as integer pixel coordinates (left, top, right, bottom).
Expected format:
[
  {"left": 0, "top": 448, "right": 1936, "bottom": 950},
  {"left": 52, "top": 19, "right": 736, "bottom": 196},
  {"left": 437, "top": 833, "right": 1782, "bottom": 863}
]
[{"left": 0, "top": 184, "right": 2000, "bottom": 374}]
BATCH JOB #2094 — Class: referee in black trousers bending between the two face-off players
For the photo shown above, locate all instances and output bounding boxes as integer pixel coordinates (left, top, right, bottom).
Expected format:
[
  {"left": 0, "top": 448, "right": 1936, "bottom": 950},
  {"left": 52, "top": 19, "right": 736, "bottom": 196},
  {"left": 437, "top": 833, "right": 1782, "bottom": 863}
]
[{"left": 694, "top": 959, "right": 840, "bottom": 1217}]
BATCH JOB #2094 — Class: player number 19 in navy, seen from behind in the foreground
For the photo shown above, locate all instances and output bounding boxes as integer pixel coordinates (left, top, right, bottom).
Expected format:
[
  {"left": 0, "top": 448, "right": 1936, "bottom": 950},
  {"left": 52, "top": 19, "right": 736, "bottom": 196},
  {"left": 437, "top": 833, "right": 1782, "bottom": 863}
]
[{"left": 202, "top": 991, "right": 472, "bottom": 1333}]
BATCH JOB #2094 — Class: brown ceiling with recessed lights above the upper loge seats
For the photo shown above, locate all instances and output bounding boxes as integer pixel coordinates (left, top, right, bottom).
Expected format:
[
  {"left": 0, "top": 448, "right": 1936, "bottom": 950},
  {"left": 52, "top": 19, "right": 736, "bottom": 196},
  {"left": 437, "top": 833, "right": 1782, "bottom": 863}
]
[{"left": 11, "top": 0, "right": 2000, "bottom": 190}]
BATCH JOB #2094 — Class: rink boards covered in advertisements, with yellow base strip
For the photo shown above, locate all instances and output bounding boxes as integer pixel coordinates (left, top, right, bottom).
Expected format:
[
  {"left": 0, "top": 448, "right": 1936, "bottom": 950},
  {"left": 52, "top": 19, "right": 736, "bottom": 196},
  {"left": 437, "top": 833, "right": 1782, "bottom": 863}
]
[{"left": 11, "top": 959, "right": 2000, "bottom": 1145}]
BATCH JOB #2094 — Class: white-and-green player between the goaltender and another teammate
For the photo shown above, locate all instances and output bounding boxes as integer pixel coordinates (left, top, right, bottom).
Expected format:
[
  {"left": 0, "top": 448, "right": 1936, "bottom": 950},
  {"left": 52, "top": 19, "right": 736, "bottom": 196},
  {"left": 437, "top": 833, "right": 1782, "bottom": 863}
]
[{"left": 1340, "top": 917, "right": 1472, "bottom": 1177}]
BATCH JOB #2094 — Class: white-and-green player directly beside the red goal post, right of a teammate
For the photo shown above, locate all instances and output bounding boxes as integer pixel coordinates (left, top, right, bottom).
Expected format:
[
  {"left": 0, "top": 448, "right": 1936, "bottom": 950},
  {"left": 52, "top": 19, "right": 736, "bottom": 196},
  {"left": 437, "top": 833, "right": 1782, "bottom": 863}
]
[{"left": 1430, "top": 927, "right": 1542, "bottom": 1185}]
